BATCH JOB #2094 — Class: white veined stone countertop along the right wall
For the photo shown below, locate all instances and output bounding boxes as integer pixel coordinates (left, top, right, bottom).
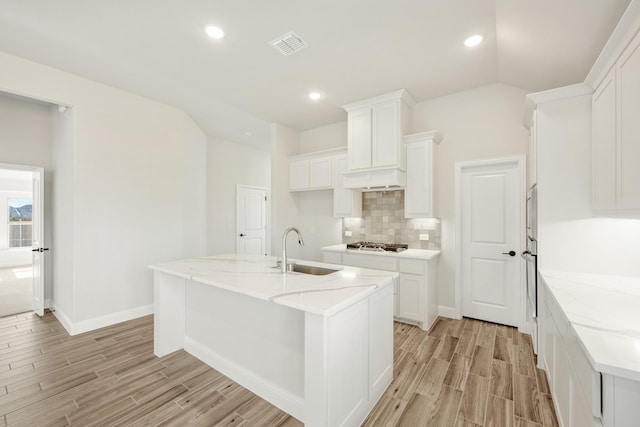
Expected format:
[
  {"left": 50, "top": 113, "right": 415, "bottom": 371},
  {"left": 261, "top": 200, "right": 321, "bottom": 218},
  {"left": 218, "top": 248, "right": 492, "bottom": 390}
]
[{"left": 540, "top": 270, "right": 640, "bottom": 381}]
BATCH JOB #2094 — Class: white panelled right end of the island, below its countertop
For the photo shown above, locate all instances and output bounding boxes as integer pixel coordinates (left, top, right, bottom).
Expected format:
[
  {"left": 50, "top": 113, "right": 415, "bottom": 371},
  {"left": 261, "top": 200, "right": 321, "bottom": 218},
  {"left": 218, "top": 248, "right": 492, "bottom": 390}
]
[{"left": 304, "top": 281, "right": 393, "bottom": 427}]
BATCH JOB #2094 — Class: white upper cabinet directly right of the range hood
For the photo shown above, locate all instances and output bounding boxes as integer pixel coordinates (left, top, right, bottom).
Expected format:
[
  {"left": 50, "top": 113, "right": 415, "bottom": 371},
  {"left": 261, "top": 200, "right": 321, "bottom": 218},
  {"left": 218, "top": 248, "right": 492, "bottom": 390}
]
[{"left": 404, "top": 131, "right": 442, "bottom": 218}]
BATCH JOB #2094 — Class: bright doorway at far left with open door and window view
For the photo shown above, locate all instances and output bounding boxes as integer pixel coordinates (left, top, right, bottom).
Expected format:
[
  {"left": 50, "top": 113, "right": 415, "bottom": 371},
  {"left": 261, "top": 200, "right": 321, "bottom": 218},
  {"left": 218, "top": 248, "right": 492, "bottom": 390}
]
[{"left": 0, "top": 164, "right": 44, "bottom": 317}]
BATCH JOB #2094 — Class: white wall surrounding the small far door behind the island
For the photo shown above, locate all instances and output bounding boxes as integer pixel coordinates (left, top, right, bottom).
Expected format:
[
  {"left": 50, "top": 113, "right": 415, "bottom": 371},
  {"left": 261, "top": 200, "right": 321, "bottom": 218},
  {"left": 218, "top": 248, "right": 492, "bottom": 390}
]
[{"left": 206, "top": 138, "right": 271, "bottom": 255}]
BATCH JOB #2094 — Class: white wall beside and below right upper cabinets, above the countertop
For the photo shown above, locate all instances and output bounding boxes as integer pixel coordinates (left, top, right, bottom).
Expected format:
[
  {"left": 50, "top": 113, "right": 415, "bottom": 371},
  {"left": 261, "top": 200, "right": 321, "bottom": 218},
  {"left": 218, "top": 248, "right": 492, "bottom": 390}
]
[{"left": 537, "top": 95, "right": 640, "bottom": 276}]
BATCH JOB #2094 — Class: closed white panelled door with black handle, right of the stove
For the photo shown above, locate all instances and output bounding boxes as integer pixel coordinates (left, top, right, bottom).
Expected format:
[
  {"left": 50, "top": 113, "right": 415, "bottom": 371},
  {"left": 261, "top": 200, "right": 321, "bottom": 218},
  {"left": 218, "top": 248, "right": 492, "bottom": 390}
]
[{"left": 460, "top": 160, "right": 524, "bottom": 326}]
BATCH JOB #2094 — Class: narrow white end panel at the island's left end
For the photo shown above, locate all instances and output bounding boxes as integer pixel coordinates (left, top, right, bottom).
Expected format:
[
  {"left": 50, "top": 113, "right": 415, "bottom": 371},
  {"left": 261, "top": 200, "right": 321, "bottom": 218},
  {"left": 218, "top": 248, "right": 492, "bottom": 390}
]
[{"left": 153, "top": 270, "right": 186, "bottom": 357}]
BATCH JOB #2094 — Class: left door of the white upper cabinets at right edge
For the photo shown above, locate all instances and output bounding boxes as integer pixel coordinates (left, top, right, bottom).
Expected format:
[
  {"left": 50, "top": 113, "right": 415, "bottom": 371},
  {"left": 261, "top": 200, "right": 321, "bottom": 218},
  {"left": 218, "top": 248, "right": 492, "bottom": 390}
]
[{"left": 591, "top": 66, "right": 616, "bottom": 209}]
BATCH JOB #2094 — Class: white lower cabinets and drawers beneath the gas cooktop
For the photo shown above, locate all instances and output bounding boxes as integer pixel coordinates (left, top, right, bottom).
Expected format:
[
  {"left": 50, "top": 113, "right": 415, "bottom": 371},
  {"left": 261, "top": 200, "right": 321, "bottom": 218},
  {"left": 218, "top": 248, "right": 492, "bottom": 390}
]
[{"left": 322, "top": 251, "right": 438, "bottom": 330}]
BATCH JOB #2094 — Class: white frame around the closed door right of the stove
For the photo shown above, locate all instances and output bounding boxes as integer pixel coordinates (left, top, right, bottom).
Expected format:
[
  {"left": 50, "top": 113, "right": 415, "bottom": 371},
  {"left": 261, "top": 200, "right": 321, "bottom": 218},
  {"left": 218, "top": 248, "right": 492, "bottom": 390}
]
[{"left": 454, "top": 155, "right": 528, "bottom": 333}]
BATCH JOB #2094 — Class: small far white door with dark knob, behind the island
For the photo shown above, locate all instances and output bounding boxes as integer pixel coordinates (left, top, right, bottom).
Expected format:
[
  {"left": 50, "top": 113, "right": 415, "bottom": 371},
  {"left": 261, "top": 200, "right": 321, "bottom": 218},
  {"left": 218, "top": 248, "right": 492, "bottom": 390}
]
[{"left": 236, "top": 185, "right": 267, "bottom": 255}]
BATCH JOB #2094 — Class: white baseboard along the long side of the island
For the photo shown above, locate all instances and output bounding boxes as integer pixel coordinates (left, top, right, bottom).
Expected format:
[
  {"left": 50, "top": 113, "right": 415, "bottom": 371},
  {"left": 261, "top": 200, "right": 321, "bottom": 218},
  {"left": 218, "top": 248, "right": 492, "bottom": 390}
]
[{"left": 184, "top": 337, "right": 304, "bottom": 420}]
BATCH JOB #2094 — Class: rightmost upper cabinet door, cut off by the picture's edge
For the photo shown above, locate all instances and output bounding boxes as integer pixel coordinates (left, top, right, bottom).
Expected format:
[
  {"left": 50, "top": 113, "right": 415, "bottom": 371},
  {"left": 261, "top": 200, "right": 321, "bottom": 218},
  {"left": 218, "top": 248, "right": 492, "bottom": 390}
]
[{"left": 616, "top": 30, "right": 640, "bottom": 209}]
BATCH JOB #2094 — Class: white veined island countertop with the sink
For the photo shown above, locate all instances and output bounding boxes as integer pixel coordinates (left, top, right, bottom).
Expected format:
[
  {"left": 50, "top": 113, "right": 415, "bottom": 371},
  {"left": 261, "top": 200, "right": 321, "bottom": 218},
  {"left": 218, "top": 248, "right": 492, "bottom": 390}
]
[{"left": 149, "top": 254, "right": 398, "bottom": 316}]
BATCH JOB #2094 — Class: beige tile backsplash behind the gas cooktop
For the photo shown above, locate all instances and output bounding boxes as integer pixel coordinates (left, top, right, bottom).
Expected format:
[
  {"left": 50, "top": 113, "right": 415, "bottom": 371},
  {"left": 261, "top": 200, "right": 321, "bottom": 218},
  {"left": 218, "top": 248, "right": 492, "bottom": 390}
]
[{"left": 342, "top": 190, "right": 441, "bottom": 249}]
